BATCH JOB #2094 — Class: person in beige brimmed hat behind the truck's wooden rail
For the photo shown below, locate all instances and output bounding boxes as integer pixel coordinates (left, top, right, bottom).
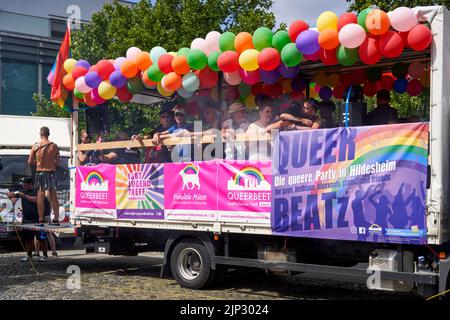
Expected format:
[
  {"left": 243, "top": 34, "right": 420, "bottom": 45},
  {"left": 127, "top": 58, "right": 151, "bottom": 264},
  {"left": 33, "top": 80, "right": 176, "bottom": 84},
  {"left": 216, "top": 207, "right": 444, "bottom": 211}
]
[{"left": 222, "top": 102, "right": 250, "bottom": 160}]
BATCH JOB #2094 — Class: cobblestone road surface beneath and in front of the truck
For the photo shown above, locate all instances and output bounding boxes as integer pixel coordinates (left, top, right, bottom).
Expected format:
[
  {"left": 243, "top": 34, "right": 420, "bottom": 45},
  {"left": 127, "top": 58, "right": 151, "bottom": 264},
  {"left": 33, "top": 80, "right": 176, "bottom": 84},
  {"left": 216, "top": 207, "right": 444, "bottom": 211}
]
[{"left": 0, "top": 248, "right": 420, "bottom": 300}]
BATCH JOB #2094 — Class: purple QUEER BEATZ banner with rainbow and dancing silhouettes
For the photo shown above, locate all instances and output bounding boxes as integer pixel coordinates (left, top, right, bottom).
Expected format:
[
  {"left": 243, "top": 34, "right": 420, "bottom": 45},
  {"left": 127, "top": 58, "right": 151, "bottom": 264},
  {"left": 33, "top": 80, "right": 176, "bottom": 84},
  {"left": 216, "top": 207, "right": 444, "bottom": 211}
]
[{"left": 271, "top": 123, "right": 429, "bottom": 244}]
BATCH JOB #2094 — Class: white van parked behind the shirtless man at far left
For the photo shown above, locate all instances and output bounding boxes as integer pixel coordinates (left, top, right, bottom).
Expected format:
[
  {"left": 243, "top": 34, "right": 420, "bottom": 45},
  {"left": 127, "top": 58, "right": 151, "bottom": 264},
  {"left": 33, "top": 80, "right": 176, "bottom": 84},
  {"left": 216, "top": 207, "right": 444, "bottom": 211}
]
[{"left": 0, "top": 115, "right": 71, "bottom": 239}]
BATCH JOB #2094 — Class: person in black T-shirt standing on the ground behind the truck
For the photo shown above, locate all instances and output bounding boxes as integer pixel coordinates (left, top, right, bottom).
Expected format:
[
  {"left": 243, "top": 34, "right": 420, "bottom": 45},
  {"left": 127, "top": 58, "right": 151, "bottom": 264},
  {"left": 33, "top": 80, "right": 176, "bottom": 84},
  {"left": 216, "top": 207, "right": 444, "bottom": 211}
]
[{"left": 7, "top": 177, "right": 50, "bottom": 262}]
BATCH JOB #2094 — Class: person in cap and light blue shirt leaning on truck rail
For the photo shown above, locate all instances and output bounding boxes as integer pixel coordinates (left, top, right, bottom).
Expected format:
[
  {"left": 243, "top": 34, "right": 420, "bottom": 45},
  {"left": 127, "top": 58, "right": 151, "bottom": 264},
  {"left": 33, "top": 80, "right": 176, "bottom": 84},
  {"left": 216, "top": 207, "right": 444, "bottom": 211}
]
[{"left": 153, "top": 105, "right": 194, "bottom": 161}]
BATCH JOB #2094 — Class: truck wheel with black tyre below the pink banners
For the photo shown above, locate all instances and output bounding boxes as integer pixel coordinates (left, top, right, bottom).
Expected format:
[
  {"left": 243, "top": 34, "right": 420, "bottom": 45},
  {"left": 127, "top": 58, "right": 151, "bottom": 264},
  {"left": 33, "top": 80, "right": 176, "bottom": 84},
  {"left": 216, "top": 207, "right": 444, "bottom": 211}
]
[{"left": 170, "top": 239, "right": 216, "bottom": 289}]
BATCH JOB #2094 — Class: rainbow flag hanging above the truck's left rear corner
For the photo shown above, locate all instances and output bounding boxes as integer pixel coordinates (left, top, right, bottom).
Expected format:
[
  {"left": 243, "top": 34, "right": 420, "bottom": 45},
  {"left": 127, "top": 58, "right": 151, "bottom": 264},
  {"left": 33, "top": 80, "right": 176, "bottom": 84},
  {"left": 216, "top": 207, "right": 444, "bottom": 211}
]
[{"left": 47, "top": 24, "right": 71, "bottom": 105}]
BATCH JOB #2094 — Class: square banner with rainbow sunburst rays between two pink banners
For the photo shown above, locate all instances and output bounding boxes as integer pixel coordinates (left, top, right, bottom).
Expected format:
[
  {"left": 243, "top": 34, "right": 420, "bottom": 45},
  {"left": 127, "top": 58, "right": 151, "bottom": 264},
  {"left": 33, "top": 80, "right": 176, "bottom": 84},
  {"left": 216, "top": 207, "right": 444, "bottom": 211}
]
[{"left": 116, "top": 164, "right": 164, "bottom": 219}]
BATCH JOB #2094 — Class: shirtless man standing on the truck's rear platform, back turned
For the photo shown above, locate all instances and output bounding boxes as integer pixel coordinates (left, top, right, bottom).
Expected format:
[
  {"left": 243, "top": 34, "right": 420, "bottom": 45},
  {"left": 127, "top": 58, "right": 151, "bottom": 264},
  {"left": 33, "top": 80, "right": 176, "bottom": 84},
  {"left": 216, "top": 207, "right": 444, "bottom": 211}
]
[{"left": 28, "top": 127, "right": 60, "bottom": 226}]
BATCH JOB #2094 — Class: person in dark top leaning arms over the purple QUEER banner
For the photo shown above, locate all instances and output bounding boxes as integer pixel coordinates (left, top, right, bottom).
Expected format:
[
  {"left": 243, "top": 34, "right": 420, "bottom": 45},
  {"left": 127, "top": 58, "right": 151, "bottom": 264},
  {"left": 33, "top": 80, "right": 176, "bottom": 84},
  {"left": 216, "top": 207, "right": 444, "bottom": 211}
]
[{"left": 266, "top": 99, "right": 321, "bottom": 132}]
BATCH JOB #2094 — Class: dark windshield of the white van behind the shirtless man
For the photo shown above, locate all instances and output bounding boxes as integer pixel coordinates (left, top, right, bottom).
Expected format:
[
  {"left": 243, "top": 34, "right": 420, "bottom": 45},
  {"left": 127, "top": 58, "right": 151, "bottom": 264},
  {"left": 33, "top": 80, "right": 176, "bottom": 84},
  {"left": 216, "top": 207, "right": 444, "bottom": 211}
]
[{"left": 0, "top": 155, "right": 70, "bottom": 188}]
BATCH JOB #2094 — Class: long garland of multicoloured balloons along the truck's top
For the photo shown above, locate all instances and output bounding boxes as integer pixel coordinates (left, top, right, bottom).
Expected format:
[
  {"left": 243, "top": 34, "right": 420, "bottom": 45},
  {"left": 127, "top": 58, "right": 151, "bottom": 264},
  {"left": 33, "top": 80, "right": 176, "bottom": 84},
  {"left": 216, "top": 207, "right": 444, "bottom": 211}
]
[{"left": 57, "top": 7, "right": 432, "bottom": 108}]
